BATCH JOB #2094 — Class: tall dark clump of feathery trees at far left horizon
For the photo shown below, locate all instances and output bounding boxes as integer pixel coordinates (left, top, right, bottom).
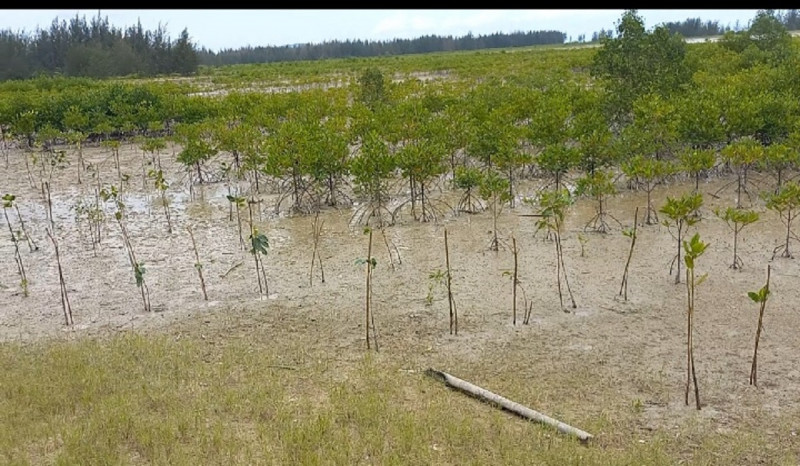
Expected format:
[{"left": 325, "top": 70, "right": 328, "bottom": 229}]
[{"left": 0, "top": 15, "right": 199, "bottom": 80}]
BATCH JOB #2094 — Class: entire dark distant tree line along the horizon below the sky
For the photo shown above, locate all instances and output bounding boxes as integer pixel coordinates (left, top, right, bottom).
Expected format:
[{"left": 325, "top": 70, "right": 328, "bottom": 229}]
[{"left": 0, "top": 10, "right": 800, "bottom": 81}]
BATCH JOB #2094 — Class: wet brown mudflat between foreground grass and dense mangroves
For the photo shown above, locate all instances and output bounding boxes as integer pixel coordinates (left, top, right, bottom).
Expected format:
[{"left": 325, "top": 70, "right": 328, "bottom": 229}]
[{"left": 0, "top": 141, "right": 800, "bottom": 434}]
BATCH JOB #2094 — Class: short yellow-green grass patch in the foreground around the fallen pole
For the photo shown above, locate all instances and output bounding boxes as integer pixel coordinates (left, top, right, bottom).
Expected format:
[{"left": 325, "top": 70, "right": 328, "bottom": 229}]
[{"left": 0, "top": 329, "right": 797, "bottom": 465}]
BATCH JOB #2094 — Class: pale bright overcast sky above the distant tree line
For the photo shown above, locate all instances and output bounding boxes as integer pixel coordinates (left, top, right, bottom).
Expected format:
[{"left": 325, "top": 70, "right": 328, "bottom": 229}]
[{"left": 0, "top": 9, "right": 758, "bottom": 51}]
